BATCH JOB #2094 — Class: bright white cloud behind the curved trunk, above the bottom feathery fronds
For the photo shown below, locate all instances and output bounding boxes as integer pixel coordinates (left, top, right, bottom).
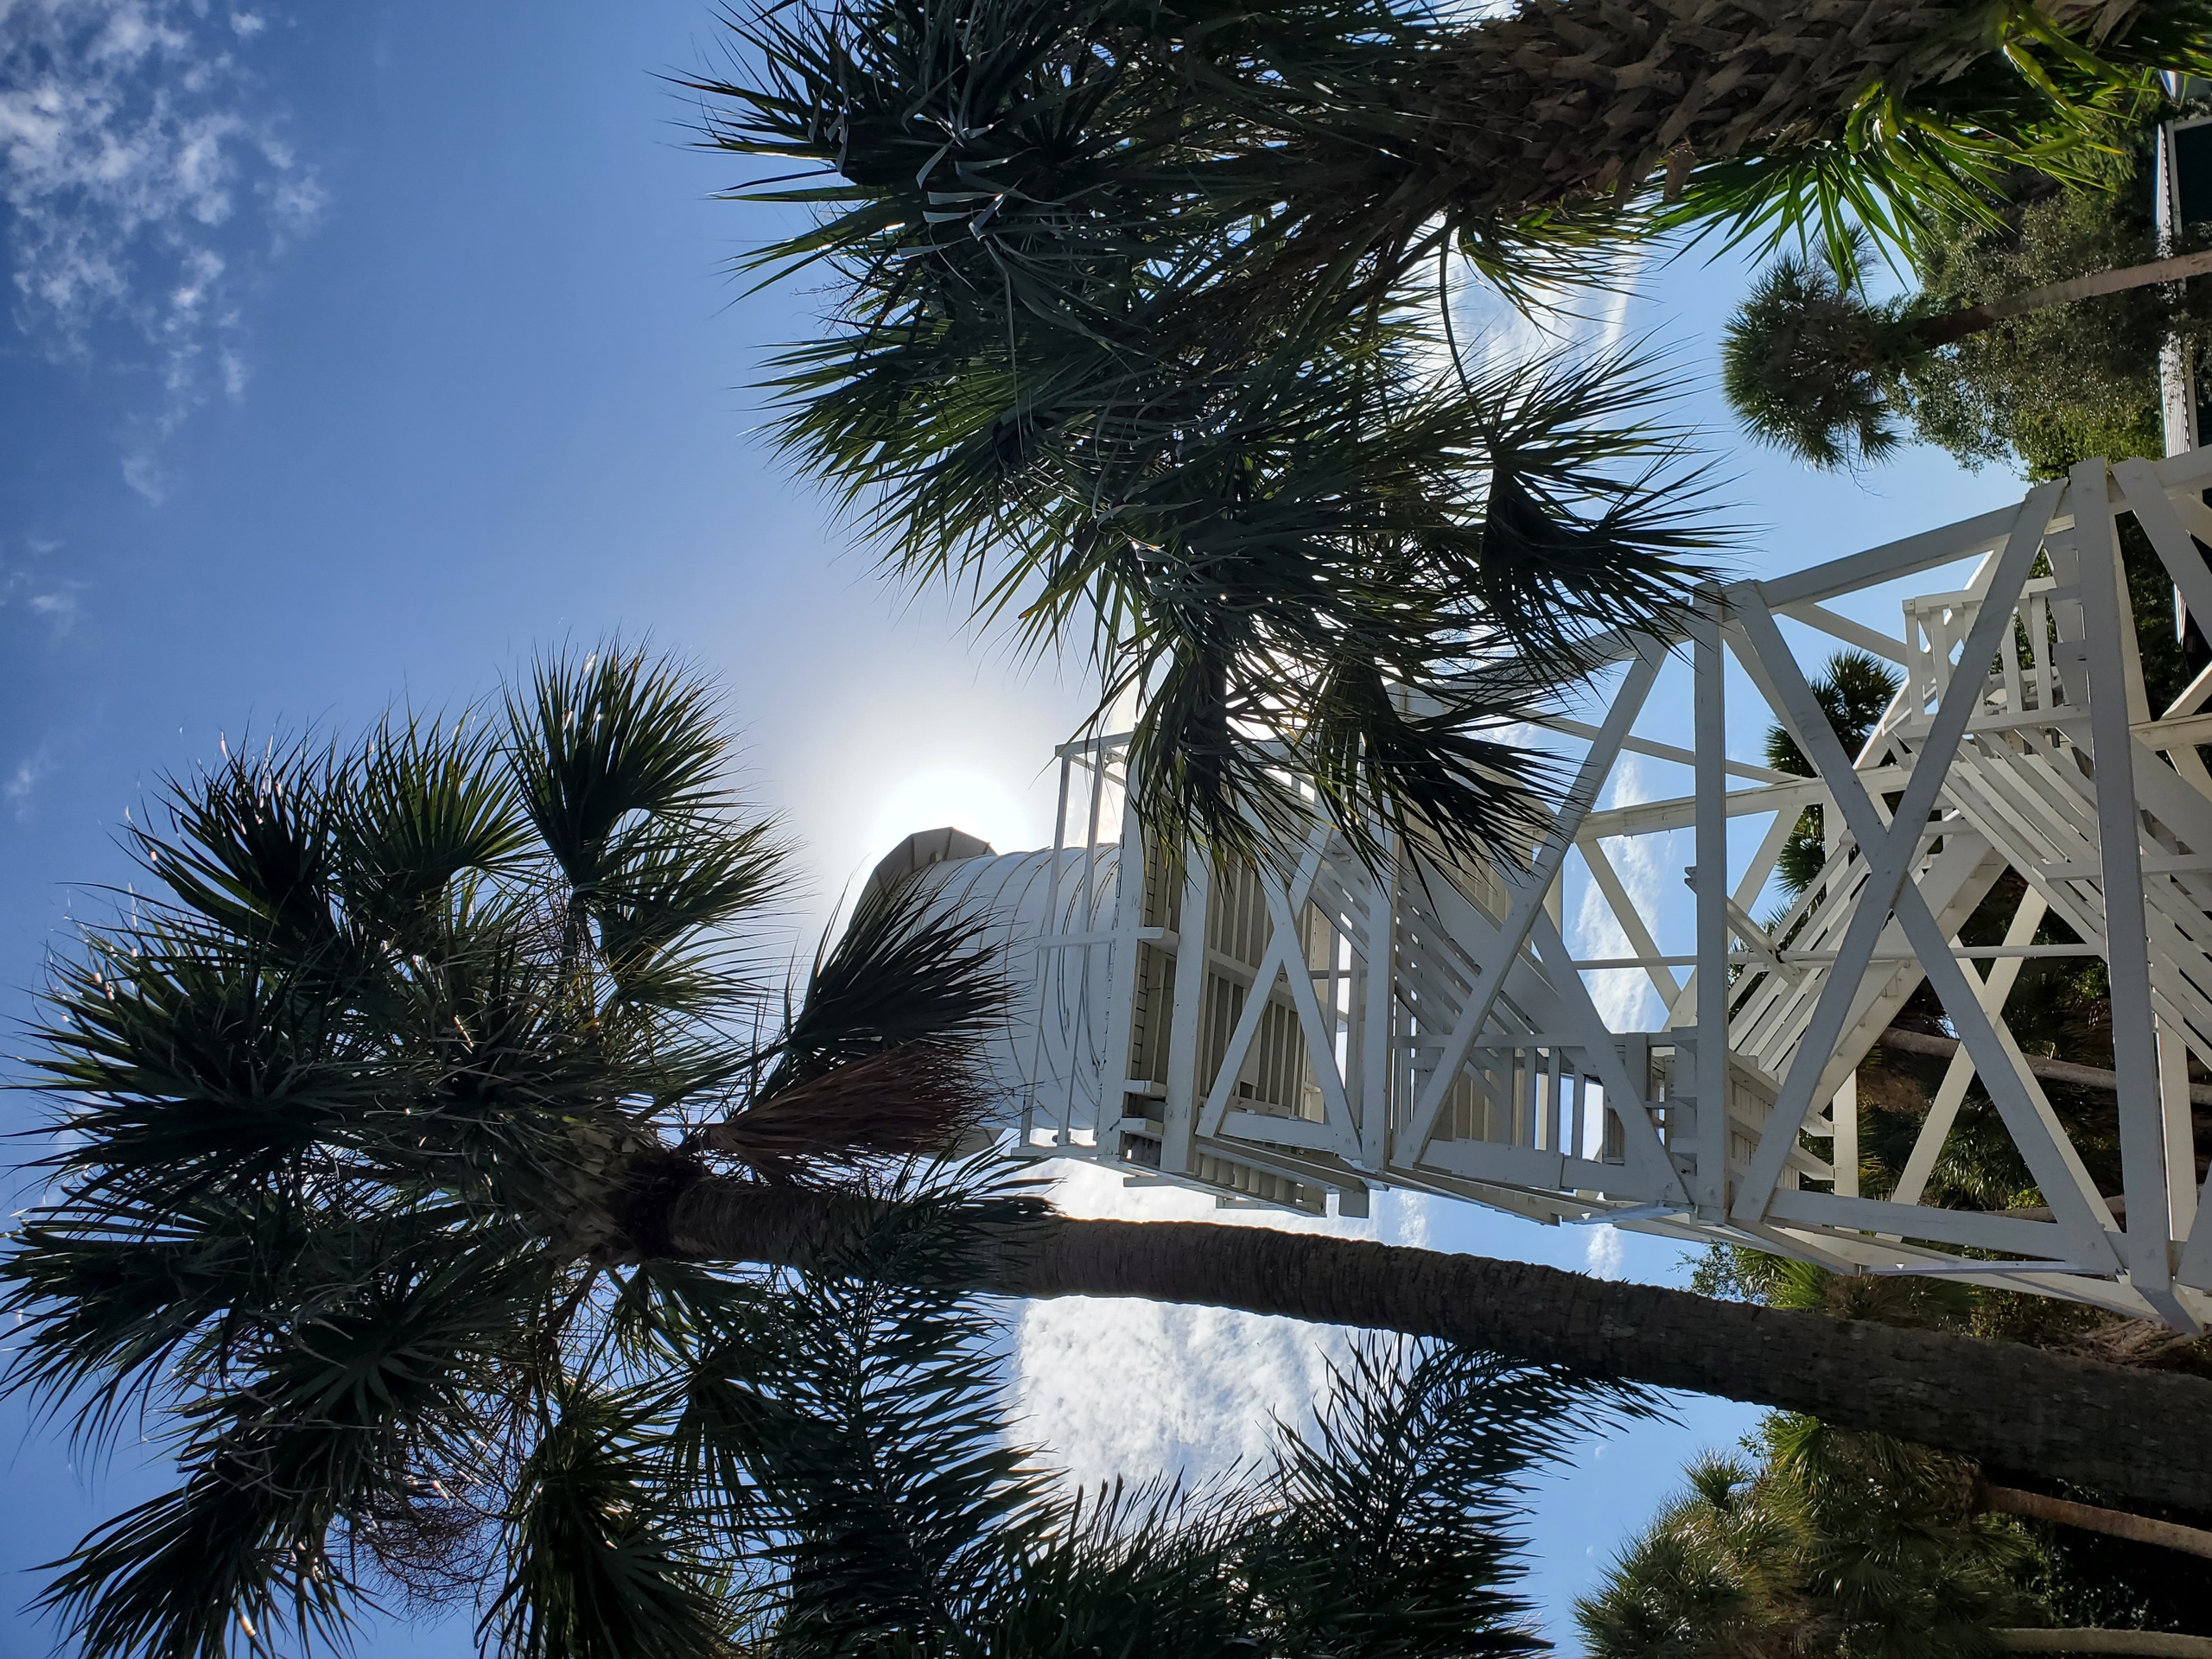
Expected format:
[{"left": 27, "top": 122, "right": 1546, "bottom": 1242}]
[{"left": 1011, "top": 1166, "right": 1429, "bottom": 1486}]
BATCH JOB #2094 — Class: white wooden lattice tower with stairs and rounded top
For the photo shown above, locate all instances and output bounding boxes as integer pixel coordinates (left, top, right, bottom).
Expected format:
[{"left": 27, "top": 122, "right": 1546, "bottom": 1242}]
[{"left": 887, "top": 449, "right": 2212, "bottom": 1330}]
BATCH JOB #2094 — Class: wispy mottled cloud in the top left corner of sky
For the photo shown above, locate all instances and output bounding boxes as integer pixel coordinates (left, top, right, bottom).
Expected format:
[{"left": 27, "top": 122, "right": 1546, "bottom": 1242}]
[{"left": 0, "top": 0, "right": 325, "bottom": 500}]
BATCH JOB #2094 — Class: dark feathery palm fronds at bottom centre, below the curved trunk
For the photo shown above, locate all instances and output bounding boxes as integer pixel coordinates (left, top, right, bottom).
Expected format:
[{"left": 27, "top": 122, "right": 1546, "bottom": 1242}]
[{"left": 698, "top": 1181, "right": 1652, "bottom": 1659}]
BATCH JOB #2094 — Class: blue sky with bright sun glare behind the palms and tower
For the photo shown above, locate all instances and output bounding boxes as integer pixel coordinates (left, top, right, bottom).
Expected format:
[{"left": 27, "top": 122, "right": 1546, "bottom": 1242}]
[{"left": 0, "top": 0, "right": 2018, "bottom": 1655}]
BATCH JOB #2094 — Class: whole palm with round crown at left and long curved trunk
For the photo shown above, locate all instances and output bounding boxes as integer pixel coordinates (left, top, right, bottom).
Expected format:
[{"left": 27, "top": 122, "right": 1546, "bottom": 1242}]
[{"left": 17, "top": 648, "right": 2212, "bottom": 1659}]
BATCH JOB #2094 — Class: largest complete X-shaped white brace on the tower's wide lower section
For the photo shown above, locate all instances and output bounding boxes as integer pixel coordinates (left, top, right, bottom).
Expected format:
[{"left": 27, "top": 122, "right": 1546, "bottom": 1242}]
[{"left": 1730, "top": 482, "right": 2119, "bottom": 1268}]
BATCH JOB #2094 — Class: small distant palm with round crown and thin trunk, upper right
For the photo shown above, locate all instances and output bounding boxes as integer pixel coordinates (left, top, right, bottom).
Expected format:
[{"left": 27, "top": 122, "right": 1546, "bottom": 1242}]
[{"left": 1721, "top": 226, "right": 2212, "bottom": 471}]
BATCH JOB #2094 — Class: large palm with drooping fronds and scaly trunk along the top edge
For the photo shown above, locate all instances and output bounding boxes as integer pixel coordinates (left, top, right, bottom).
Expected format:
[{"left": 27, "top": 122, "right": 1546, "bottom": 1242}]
[{"left": 692, "top": 0, "right": 2212, "bottom": 852}]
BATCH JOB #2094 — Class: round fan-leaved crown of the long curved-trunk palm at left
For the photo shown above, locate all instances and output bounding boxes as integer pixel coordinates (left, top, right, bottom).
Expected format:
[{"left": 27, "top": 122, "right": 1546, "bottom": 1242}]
[{"left": 0, "top": 646, "right": 1030, "bottom": 1659}]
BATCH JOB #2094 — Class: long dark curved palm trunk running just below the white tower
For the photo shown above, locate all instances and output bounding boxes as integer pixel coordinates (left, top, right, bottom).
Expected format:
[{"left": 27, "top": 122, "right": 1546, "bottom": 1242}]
[{"left": 648, "top": 1177, "right": 2212, "bottom": 1510}]
